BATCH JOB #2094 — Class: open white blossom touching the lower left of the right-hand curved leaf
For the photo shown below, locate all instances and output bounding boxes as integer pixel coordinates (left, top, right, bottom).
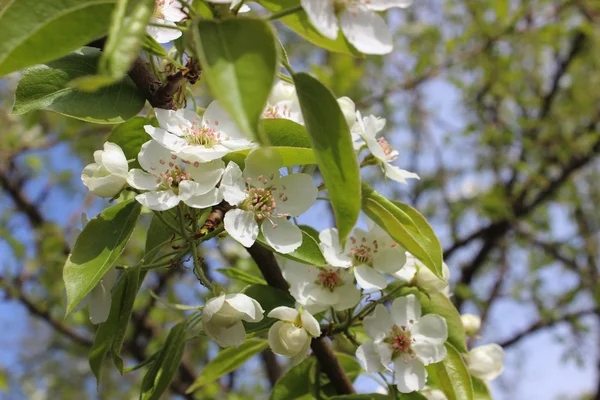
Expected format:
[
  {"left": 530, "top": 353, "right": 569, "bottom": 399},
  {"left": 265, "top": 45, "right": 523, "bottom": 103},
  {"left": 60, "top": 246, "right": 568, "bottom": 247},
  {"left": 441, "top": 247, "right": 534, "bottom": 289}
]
[{"left": 319, "top": 221, "right": 406, "bottom": 290}]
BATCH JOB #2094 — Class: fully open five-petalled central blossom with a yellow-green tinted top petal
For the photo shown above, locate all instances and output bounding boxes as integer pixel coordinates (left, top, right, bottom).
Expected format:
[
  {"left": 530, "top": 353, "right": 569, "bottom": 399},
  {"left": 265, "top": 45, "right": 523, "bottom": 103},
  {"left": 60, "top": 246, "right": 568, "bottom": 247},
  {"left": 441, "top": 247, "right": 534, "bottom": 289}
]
[{"left": 221, "top": 148, "right": 317, "bottom": 254}]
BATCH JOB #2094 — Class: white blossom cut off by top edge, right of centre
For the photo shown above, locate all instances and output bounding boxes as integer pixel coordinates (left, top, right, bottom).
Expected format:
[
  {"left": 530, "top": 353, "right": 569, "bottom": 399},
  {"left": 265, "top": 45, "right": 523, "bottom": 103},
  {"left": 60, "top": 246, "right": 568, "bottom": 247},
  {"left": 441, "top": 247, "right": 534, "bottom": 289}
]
[{"left": 301, "top": 0, "right": 412, "bottom": 54}]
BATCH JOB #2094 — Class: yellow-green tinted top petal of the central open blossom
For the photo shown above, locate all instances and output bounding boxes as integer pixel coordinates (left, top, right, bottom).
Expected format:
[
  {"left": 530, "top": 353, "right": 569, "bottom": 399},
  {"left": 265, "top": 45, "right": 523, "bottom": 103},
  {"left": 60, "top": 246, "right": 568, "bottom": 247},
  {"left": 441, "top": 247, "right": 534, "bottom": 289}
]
[{"left": 244, "top": 147, "right": 283, "bottom": 187}]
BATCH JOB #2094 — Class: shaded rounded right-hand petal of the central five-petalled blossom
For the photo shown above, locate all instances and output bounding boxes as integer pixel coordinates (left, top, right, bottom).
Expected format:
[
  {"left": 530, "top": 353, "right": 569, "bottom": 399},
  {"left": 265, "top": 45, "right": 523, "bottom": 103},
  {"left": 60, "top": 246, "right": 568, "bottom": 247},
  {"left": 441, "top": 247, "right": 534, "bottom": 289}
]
[{"left": 276, "top": 174, "right": 318, "bottom": 217}]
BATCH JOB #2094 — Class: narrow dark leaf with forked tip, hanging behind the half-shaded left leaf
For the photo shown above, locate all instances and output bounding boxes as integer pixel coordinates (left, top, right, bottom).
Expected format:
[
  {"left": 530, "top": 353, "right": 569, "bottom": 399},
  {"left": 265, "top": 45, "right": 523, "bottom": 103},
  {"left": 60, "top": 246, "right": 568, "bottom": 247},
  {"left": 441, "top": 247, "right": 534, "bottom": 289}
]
[{"left": 89, "top": 268, "right": 145, "bottom": 385}]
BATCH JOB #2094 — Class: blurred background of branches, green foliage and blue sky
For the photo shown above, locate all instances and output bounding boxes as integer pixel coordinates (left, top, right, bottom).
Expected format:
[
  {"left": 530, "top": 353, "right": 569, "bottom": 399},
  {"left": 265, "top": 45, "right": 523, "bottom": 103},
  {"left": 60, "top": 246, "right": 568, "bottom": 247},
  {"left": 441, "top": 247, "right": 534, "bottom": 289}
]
[{"left": 0, "top": 0, "right": 600, "bottom": 400}]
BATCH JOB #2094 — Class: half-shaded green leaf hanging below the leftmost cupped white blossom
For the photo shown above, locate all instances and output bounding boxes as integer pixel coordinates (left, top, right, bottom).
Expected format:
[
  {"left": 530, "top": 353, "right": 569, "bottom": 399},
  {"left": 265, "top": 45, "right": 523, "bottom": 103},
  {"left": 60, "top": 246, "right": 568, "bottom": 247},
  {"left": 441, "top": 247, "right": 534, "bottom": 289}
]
[{"left": 63, "top": 199, "right": 142, "bottom": 314}]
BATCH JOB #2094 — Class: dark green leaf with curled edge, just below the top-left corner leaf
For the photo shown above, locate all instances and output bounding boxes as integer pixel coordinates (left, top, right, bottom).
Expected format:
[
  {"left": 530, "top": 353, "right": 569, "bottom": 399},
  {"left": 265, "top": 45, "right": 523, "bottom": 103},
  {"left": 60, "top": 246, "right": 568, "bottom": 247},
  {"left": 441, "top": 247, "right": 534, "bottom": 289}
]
[{"left": 13, "top": 47, "right": 146, "bottom": 124}]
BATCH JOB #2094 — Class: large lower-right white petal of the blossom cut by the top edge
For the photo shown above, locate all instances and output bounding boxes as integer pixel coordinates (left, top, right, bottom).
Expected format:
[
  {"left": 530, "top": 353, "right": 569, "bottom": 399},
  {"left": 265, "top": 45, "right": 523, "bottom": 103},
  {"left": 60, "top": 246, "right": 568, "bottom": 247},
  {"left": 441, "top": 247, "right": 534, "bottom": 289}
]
[{"left": 340, "top": 7, "right": 393, "bottom": 54}]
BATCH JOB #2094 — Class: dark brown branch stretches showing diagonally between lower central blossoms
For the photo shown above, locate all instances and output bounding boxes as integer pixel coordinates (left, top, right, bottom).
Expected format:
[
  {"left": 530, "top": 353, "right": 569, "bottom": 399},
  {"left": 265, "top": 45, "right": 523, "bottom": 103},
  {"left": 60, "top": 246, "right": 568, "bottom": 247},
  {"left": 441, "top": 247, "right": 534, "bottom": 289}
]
[{"left": 247, "top": 244, "right": 355, "bottom": 394}]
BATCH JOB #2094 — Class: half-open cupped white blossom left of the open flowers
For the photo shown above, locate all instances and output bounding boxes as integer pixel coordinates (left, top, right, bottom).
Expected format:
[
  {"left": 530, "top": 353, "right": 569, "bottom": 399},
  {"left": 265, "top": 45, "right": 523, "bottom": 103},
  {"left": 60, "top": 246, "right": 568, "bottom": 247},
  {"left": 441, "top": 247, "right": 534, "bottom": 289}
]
[{"left": 81, "top": 142, "right": 129, "bottom": 198}]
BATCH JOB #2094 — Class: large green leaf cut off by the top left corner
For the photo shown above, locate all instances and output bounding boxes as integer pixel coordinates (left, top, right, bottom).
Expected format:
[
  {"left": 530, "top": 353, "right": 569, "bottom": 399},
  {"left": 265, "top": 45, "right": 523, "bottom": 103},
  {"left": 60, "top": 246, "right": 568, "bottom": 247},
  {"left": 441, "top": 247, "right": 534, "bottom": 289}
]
[{"left": 0, "top": 0, "right": 115, "bottom": 76}]
